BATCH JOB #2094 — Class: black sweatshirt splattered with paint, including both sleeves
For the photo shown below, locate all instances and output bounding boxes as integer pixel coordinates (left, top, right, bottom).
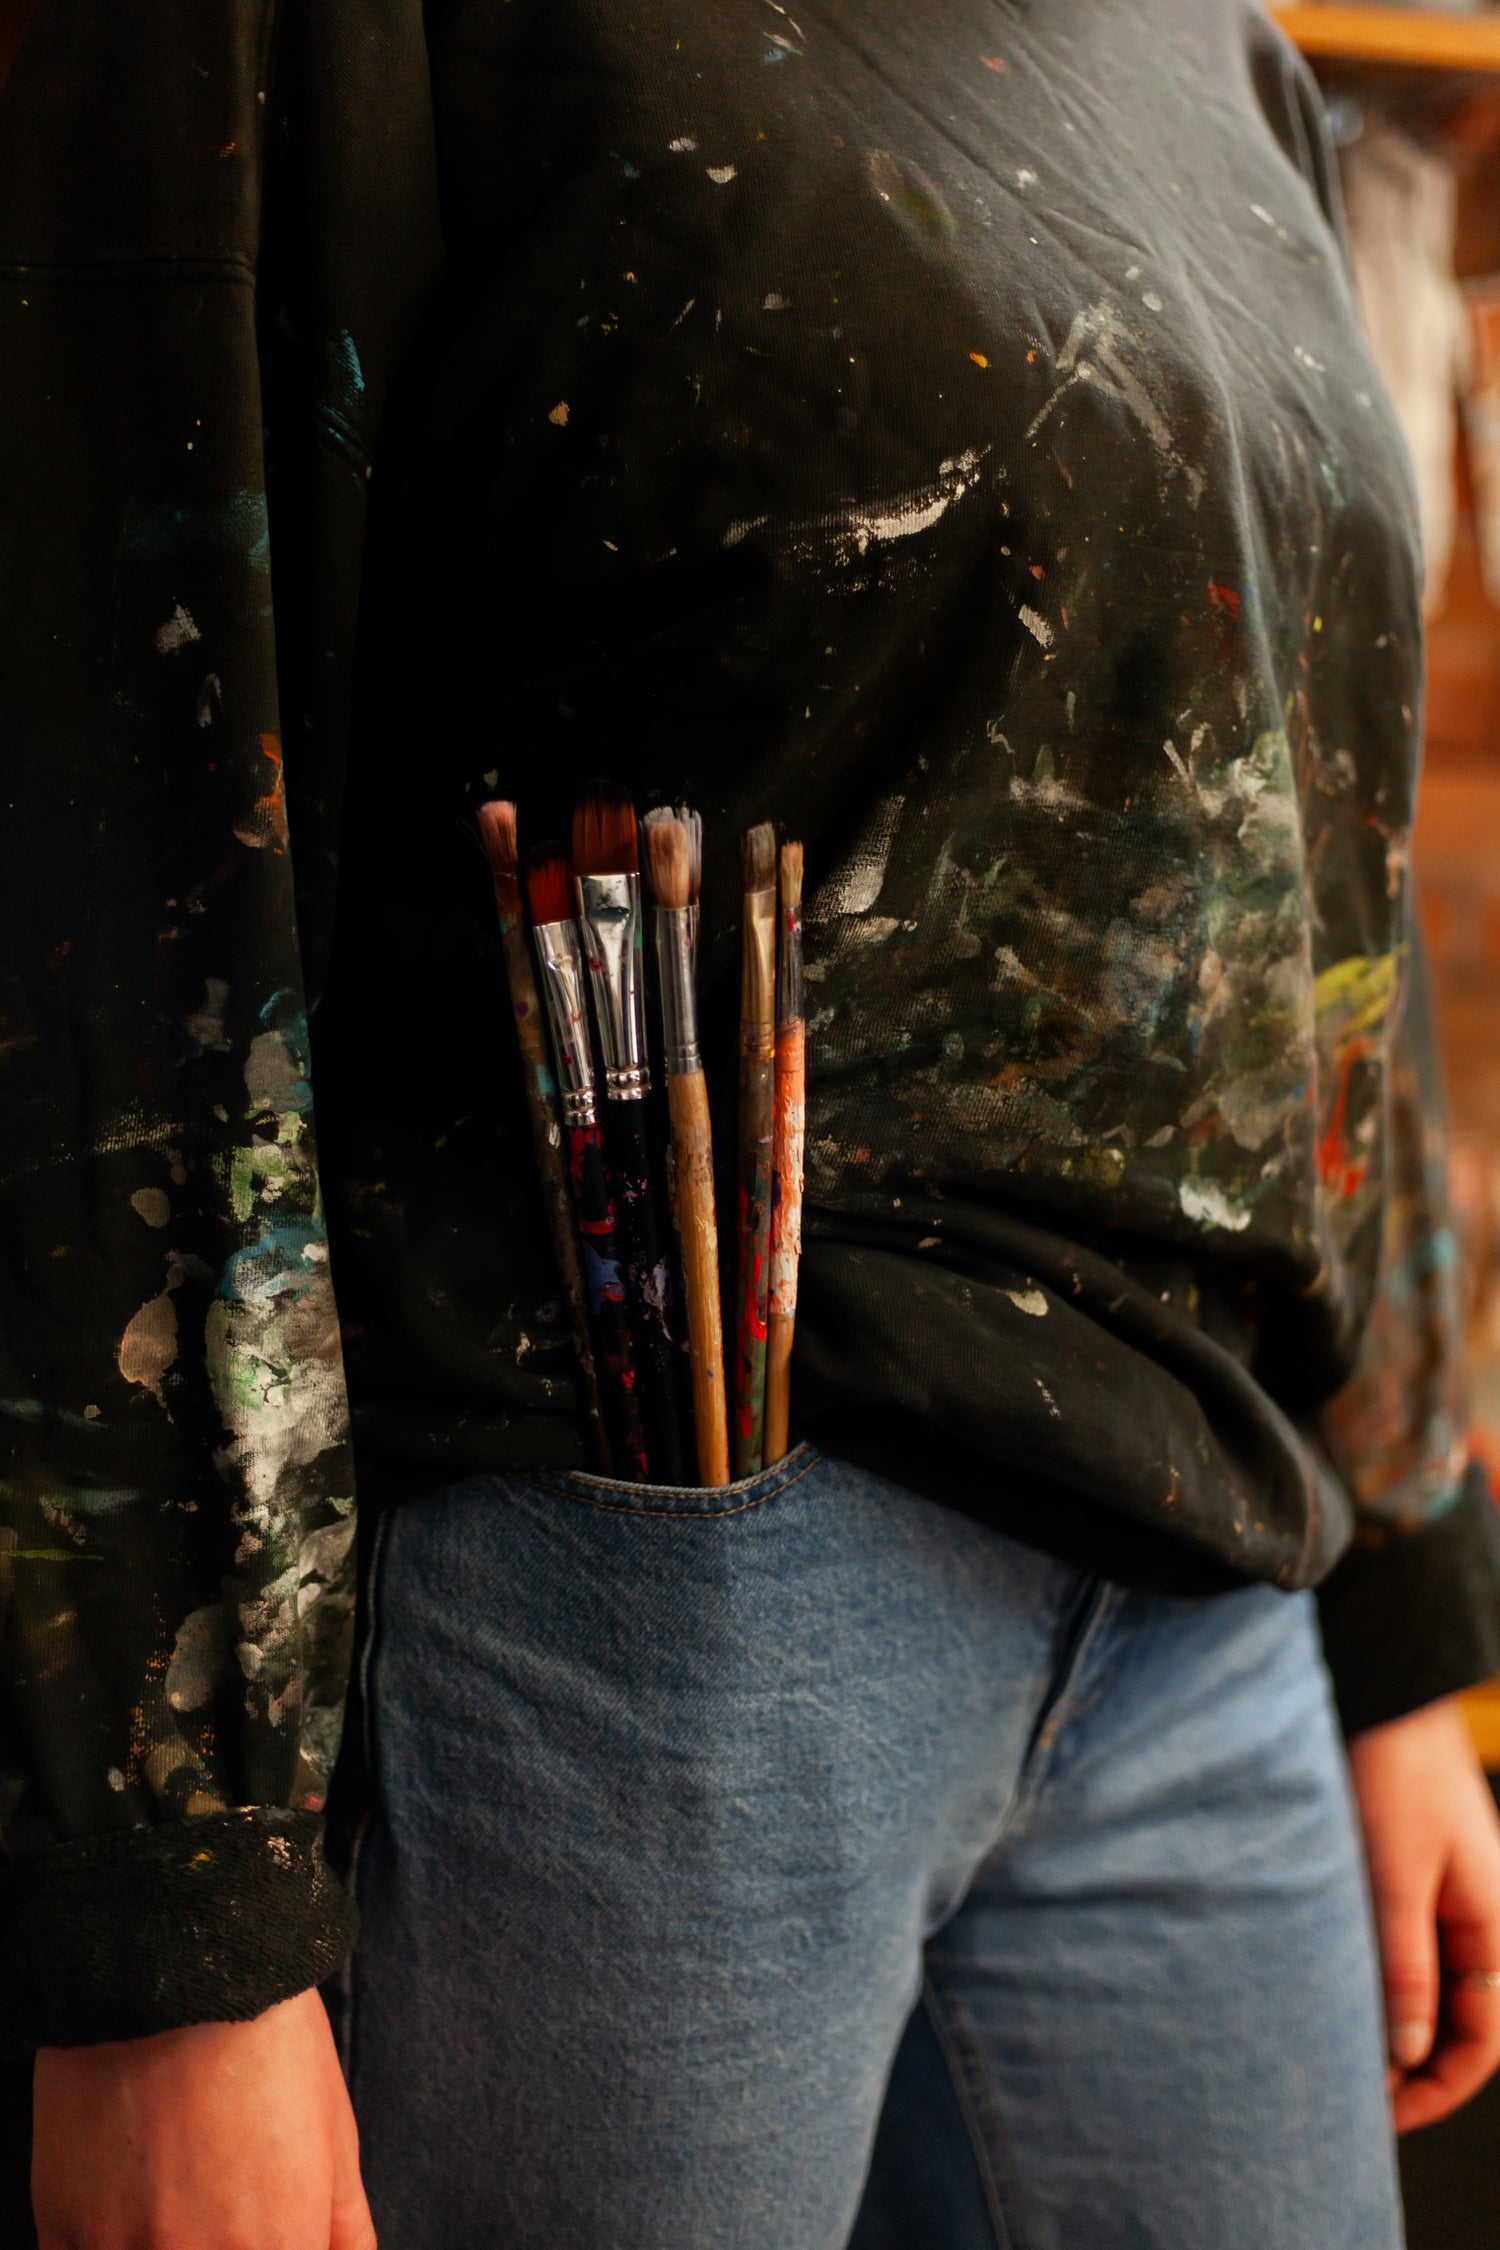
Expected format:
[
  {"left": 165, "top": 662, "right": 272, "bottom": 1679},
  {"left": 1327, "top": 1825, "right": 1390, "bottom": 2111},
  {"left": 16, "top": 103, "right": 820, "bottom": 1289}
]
[{"left": 0, "top": 0, "right": 1500, "bottom": 2043}]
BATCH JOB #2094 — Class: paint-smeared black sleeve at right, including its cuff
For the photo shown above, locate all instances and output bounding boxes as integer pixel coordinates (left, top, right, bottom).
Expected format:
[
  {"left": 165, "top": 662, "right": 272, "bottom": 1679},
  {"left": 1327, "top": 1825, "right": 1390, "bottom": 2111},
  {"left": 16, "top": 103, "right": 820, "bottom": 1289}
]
[{"left": 1318, "top": 931, "right": 1500, "bottom": 1733}]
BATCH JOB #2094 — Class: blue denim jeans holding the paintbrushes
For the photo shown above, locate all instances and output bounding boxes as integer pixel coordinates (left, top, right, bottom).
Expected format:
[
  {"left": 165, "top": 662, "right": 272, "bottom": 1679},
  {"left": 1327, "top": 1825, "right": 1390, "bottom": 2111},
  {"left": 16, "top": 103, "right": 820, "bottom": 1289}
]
[{"left": 344, "top": 1447, "right": 1401, "bottom": 2250}]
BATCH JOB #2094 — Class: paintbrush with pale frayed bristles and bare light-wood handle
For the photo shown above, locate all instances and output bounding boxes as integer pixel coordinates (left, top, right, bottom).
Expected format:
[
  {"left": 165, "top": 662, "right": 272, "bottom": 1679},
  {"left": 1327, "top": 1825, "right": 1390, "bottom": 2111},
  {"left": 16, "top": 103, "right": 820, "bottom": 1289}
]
[{"left": 645, "top": 812, "right": 729, "bottom": 1485}]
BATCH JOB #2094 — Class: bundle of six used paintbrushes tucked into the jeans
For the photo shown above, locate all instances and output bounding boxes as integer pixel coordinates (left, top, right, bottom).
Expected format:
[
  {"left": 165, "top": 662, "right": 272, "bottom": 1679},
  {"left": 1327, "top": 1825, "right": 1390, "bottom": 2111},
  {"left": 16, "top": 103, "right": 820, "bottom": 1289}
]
[{"left": 481, "top": 785, "right": 803, "bottom": 1485}]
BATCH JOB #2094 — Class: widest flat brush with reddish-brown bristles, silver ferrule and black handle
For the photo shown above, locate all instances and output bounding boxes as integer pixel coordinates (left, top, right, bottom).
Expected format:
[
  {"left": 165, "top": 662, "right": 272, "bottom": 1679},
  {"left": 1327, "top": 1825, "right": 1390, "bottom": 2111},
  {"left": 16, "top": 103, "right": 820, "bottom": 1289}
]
[{"left": 573, "top": 781, "right": 684, "bottom": 1485}]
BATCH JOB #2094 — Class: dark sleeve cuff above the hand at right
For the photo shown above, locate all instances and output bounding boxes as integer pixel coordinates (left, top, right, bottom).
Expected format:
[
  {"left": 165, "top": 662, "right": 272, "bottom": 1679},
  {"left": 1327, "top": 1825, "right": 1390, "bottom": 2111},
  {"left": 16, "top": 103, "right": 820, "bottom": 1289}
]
[{"left": 1318, "top": 1463, "right": 1500, "bottom": 1735}]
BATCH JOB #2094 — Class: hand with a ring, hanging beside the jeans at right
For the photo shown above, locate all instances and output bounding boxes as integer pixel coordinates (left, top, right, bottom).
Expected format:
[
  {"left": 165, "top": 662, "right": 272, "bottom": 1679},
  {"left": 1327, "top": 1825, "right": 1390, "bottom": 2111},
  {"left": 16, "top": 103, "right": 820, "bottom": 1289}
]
[{"left": 1349, "top": 1699, "right": 1500, "bottom": 2133}]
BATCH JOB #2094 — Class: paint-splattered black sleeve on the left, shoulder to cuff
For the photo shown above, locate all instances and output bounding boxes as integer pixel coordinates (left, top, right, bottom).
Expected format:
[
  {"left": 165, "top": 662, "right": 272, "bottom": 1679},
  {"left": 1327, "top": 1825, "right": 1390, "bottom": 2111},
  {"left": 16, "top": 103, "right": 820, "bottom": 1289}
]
[{"left": 0, "top": 0, "right": 445, "bottom": 2045}]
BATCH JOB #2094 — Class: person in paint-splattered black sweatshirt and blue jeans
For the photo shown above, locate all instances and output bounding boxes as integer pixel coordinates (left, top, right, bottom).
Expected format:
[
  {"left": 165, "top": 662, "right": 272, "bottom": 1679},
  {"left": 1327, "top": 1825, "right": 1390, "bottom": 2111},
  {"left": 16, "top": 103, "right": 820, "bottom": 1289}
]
[{"left": 0, "top": 0, "right": 1500, "bottom": 2250}]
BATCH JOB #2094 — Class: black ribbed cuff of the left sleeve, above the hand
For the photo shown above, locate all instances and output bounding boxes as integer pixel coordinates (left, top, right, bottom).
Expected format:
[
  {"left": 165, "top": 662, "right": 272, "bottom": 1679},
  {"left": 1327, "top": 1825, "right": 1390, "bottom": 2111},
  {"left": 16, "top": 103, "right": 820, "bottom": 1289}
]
[{"left": 0, "top": 1805, "right": 358, "bottom": 2048}]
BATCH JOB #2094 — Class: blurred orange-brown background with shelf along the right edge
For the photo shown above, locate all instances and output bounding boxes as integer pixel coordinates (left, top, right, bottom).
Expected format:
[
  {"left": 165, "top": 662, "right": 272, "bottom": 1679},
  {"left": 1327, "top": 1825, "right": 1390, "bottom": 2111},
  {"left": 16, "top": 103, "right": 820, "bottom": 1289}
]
[{"left": 1273, "top": 0, "right": 1500, "bottom": 2250}]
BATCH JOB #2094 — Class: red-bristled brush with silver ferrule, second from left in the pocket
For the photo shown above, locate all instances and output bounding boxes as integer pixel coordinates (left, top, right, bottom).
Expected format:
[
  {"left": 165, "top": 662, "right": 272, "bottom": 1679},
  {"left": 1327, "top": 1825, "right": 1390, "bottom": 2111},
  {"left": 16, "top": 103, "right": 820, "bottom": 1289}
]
[{"left": 526, "top": 846, "right": 652, "bottom": 1483}]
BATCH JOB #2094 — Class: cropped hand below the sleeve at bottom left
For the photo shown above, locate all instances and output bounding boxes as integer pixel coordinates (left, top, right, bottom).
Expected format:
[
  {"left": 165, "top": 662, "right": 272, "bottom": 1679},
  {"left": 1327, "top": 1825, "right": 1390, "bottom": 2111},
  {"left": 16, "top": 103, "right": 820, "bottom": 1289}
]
[{"left": 31, "top": 1991, "right": 376, "bottom": 2250}]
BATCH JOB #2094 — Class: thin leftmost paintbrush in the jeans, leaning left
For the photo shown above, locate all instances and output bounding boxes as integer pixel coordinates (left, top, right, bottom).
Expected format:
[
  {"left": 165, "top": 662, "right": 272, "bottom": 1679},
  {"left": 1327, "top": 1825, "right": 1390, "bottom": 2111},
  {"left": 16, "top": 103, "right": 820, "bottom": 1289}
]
[{"left": 479, "top": 799, "right": 609, "bottom": 1474}]
